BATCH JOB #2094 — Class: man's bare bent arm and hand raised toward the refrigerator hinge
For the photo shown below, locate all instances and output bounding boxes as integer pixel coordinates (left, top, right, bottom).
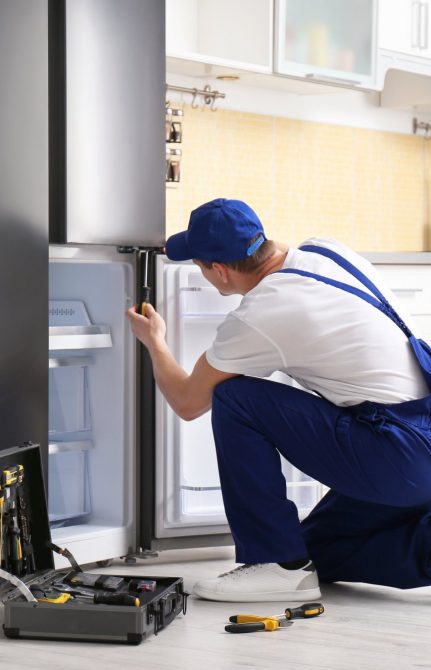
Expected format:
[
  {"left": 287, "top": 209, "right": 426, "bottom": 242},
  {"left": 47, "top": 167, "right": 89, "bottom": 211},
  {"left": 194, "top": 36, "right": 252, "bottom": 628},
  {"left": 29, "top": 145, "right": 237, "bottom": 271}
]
[{"left": 127, "top": 304, "right": 238, "bottom": 421}]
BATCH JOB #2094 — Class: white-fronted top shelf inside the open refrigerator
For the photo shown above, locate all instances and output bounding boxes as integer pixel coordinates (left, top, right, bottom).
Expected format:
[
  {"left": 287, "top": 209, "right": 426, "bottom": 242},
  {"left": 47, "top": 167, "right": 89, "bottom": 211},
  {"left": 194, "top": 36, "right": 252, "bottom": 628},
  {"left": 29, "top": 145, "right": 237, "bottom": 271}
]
[{"left": 49, "top": 326, "right": 112, "bottom": 351}]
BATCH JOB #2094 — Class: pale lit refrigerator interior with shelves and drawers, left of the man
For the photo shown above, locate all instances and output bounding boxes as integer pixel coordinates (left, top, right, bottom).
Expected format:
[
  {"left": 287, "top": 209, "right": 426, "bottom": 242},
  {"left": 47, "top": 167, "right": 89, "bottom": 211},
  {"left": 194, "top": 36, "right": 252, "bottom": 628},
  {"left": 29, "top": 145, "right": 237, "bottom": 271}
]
[{"left": 48, "top": 246, "right": 136, "bottom": 565}]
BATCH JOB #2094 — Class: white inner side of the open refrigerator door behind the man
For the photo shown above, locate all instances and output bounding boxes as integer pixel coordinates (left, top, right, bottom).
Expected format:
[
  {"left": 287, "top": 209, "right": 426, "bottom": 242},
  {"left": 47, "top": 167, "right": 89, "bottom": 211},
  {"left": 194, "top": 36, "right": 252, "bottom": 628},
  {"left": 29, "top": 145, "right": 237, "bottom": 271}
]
[{"left": 155, "top": 257, "right": 324, "bottom": 538}]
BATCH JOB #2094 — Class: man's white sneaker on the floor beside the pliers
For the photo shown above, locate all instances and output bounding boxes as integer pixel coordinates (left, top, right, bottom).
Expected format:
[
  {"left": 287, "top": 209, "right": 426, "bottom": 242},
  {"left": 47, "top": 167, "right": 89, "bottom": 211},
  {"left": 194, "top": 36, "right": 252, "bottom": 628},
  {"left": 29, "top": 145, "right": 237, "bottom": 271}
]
[{"left": 193, "top": 561, "right": 321, "bottom": 603}]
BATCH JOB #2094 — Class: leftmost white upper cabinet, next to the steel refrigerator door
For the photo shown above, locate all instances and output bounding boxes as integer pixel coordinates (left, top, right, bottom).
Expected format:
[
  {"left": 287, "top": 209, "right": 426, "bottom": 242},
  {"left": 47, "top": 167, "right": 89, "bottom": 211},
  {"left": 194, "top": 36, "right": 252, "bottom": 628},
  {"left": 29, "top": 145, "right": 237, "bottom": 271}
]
[{"left": 166, "top": 0, "right": 273, "bottom": 72}]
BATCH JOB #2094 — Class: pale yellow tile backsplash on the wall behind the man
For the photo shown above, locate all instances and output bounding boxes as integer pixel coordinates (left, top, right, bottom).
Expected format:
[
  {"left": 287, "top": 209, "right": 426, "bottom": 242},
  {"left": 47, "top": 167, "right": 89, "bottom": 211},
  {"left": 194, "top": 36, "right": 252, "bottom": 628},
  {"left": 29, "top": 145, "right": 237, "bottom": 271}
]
[{"left": 166, "top": 106, "right": 431, "bottom": 251}]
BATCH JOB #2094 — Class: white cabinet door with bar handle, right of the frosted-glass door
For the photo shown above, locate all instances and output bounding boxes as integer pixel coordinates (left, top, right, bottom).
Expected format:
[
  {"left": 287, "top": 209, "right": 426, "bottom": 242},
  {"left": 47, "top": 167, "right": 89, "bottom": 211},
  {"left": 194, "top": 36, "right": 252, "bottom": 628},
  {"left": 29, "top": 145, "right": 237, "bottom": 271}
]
[{"left": 378, "top": 0, "right": 427, "bottom": 55}]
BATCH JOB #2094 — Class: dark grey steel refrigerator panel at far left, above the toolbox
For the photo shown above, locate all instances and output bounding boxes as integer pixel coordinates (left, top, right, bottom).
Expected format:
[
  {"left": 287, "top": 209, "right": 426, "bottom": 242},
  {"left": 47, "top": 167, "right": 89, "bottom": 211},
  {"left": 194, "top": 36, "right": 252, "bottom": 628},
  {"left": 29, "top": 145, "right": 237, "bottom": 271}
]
[{"left": 0, "top": 0, "right": 48, "bottom": 466}]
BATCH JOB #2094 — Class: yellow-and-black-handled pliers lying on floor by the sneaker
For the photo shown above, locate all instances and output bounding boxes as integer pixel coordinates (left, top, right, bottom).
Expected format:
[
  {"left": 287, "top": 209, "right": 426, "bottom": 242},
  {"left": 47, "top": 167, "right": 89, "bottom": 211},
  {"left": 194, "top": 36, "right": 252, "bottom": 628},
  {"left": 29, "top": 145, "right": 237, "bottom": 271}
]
[{"left": 225, "top": 603, "right": 324, "bottom": 633}]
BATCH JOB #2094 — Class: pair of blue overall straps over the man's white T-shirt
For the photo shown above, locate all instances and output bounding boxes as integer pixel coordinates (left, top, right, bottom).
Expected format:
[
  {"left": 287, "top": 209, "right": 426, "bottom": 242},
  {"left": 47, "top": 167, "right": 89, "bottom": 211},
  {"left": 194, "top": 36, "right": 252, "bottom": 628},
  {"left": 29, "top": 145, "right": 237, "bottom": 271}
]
[{"left": 279, "top": 245, "right": 412, "bottom": 338}]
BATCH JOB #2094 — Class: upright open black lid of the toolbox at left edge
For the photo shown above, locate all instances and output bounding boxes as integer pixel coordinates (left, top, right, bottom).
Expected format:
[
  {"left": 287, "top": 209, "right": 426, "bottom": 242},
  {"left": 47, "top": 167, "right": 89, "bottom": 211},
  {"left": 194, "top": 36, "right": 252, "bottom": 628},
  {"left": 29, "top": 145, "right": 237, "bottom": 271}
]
[{"left": 0, "top": 443, "right": 54, "bottom": 600}]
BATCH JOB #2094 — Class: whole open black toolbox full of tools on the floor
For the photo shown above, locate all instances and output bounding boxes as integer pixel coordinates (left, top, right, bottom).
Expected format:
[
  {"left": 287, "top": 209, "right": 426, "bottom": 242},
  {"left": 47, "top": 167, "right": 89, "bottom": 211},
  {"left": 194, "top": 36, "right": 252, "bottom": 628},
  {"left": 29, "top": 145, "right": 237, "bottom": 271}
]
[{"left": 0, "top": 443, "right": 188, "bottom": 644}]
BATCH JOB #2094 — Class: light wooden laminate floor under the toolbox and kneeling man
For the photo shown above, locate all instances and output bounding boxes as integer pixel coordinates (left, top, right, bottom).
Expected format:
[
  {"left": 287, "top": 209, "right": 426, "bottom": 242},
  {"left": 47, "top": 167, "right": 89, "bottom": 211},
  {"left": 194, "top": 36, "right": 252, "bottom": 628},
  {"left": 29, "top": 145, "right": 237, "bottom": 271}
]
[{"left": 0, "top": 547, "right": 431, "bottom": 670}]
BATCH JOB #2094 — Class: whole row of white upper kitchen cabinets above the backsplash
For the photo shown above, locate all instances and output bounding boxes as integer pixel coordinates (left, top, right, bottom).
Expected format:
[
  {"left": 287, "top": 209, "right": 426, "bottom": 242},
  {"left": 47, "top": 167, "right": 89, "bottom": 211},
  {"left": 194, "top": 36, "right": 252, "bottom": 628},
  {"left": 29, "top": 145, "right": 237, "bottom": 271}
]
[{"left": 166, "top": 0, "right": 431, "bottom": 103}]
